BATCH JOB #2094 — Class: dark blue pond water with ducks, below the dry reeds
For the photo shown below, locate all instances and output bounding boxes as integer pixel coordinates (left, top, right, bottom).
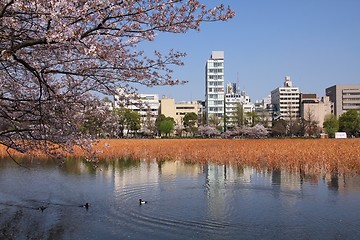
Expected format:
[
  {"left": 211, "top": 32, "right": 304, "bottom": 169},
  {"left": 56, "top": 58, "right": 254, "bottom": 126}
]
[{"left": 0, "top": 160, "right": 360, "bottom": 239}]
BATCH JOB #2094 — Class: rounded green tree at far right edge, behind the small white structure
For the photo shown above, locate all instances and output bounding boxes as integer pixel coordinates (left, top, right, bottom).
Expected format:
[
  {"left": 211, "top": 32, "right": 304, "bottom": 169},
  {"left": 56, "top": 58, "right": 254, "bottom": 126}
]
[{"left": 339, "top": 109, "right": 360, "bottom": 137}]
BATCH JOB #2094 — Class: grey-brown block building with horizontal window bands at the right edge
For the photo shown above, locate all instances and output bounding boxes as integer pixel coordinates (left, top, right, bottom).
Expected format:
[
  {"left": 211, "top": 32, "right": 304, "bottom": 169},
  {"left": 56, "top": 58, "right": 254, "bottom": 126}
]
[{"left": 325, "top": 84, "right": 360, "bottom": 117}]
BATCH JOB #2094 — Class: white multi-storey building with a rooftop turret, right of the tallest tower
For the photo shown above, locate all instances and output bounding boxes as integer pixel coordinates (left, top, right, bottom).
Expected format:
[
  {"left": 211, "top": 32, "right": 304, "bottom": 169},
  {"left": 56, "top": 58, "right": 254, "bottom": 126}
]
[{"left": 271, "top": 76, "right": 300, "bottom": 120}]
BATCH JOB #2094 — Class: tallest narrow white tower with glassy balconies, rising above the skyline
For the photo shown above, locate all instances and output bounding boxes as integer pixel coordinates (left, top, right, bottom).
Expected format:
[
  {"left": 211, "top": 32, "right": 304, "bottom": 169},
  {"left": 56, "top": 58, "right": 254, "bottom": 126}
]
[{"left": 205, "top": 51, "right": 225, "bottom": 124}]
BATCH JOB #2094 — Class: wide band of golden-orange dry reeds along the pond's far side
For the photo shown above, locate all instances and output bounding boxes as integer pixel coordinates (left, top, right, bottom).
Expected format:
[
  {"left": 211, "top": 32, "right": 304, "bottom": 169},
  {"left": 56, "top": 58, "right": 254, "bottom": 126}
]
[{"left": 0, "top": 139, "right": 360, "bottom": 174}]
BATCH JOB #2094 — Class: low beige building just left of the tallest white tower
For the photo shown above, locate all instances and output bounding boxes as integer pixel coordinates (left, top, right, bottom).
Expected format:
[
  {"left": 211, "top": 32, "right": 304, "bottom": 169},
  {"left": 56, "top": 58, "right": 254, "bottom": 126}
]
[{"left": 160, "top": 97, "right": 202, "bottom": 125}]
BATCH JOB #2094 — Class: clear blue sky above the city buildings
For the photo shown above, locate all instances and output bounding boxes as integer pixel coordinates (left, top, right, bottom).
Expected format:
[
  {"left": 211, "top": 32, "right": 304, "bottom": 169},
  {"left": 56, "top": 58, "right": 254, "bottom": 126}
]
[{"left": 139, "top": 0, "right": 360, "bottom": 102}]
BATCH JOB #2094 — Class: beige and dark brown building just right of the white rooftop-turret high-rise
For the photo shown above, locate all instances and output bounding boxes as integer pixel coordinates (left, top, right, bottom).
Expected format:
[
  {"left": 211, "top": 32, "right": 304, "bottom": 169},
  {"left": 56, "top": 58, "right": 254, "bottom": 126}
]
[{"left": 300, "top": 93, "right": 331, "bottom": 128}]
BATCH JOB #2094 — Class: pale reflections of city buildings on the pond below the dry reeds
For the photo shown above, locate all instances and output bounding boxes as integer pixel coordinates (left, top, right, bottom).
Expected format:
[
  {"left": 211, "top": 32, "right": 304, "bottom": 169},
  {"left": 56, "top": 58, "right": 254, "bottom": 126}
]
[{"left": 91, "top": 160, "right": 360, "bottom": 212}]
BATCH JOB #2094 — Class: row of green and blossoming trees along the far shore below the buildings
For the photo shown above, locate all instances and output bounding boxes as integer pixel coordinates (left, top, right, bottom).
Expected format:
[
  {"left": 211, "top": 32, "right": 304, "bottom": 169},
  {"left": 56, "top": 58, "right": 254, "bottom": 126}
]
[{"left": 77, "top": 101, "right": 360, "bottom": 138}]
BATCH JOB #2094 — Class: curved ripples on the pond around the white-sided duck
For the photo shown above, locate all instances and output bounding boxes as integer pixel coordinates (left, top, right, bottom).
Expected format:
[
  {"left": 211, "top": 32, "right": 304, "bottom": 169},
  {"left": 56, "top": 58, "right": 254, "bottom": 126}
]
[{"left": 109, "top": 173, "right": 243, "bottom": 238}]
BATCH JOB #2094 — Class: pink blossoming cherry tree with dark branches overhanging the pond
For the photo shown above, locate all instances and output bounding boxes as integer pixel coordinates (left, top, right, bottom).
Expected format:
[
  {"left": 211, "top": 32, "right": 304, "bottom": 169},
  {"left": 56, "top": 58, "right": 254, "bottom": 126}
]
[{"left": 0, "top": 0, "right": 234, "bottom": 156}]
